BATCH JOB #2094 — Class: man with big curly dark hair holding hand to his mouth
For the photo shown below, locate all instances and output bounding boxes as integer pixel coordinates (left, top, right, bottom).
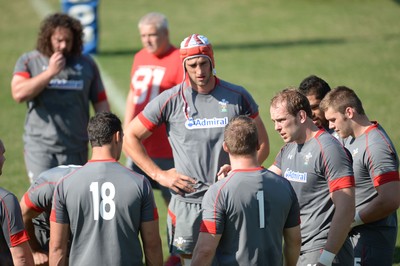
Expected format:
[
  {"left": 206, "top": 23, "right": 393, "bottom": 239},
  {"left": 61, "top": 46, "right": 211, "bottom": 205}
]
[{"left": 11, "top": 13, "right": 109, "bottom": 182}]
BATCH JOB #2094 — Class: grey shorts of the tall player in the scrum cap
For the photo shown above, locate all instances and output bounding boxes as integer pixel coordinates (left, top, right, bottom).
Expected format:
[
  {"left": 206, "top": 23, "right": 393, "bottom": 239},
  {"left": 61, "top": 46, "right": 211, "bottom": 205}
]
[{"left": 167, "top": 196, "right": 202, "bottom": 254}]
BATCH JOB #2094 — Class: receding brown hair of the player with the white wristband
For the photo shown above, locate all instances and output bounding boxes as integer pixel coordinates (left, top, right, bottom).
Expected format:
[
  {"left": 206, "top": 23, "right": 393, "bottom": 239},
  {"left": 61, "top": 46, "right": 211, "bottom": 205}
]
[{"left": 271, "top": 87, "right": 312, "bottom": 118}]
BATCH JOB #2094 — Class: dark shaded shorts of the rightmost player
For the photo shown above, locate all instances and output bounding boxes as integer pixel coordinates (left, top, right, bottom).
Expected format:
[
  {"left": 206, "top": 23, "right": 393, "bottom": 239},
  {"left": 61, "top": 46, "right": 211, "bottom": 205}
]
[{"left": 350, "top": 225, "right": 397, "bottom": 266}]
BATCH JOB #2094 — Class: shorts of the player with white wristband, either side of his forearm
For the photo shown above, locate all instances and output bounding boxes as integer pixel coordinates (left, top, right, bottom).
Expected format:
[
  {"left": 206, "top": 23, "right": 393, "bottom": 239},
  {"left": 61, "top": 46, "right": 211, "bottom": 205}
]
[{"left": 297, "top": 239, "right": 355, "bottom": 266}]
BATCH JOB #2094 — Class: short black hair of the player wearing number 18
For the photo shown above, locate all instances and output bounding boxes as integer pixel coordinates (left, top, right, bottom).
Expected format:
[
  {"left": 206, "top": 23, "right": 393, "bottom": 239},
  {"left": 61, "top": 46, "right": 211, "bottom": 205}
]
[{"left": 87, "top": 112, "right": 122, "bottom": 147}]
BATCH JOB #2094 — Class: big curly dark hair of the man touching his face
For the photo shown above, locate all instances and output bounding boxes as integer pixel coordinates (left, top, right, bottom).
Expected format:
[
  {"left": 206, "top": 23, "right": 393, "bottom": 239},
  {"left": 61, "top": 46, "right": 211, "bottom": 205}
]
[{"left": 36, "top": 13, "right": 83, "bottom": 57}]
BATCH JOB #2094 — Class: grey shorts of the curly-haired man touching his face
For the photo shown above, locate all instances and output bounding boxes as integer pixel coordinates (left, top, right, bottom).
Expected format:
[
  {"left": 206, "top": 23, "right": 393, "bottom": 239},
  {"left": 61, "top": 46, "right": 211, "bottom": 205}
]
[{"left": 24, "top": 150, "right": 88, "bottom": 183}]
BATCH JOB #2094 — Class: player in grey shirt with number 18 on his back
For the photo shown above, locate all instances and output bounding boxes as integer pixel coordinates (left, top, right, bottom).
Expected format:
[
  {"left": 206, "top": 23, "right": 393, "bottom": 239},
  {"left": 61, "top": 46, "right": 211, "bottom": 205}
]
[{"left": 49, "top": 112, "right": 163, "bottom": 266}]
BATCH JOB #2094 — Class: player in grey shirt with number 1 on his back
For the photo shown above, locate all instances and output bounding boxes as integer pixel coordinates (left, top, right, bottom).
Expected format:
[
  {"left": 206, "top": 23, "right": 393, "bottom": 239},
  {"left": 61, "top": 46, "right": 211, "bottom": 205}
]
[{"left": 192, "top": 116, "right": 301, "bottom": 266}]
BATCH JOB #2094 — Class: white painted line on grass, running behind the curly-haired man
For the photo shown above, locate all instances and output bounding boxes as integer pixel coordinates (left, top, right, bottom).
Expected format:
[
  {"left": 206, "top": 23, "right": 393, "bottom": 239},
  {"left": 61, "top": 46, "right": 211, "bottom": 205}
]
[{"left": 30, "top": 0, "right": 126, "bottom": 118}]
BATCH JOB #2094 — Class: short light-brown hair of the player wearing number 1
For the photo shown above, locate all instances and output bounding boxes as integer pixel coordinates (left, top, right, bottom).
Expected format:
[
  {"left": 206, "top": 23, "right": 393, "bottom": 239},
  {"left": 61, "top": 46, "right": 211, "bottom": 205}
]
[{"left": 224, "top": 115, "right": 258, "bottom": 155}]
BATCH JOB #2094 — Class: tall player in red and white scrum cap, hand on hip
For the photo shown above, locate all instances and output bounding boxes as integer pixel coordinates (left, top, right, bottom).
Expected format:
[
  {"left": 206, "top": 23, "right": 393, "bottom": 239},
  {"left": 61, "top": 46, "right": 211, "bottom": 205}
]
[{"left": 124, "top": 34, "right": 269, "bottom": 265}]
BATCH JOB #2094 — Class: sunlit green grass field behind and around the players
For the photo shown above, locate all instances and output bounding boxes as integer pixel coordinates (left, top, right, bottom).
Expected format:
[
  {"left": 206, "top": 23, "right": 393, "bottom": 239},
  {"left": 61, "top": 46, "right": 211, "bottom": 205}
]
[{"left": 0, "top": 0, "right": 400, "bottom": 265}]
